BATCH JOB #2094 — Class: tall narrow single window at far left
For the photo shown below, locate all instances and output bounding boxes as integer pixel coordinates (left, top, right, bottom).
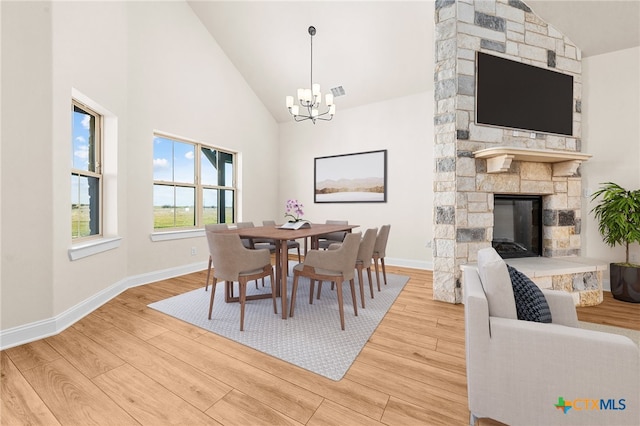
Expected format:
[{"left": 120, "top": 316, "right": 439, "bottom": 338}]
[{"left": 71, "top": 100, "right": 102, "bottom": 239}]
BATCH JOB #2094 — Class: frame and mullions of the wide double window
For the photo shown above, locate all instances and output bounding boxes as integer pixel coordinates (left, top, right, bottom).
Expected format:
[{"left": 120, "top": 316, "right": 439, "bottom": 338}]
[{"left": 152, "top": 131, "right": 239, "bottom": 233}]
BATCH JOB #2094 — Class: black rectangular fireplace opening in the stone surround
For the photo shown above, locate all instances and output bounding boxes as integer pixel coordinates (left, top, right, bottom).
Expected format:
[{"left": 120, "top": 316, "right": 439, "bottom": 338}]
[{"left": 492, "top": 194, "right": 542, "bottom": 259}]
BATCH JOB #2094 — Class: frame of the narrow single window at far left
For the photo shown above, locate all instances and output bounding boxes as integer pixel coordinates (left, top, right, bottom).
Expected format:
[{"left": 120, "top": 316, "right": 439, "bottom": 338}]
[{"left": 70, "top": 97, "right": 105, "bottom": 244}]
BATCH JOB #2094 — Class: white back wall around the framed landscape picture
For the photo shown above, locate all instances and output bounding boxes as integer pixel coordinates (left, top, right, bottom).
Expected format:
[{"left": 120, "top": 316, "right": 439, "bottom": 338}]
[{"left": 278, "top": 92, "right": 433, "bottom": 269}]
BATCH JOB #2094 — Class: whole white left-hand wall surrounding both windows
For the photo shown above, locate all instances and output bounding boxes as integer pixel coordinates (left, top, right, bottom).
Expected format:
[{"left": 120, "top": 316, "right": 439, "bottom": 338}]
[{"left": 0, "top": 1, "right": 278, "bottom": 332}]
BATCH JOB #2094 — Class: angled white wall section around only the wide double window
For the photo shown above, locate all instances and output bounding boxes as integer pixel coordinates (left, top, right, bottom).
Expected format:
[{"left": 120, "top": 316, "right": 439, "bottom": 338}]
[{"left": 127, "top": 2, "right": 278, "bottom": 275}]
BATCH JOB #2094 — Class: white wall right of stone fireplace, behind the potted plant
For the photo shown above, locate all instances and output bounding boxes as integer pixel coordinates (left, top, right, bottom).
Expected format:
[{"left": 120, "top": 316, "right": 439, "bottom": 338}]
[{"left": 580, "top": 47, "right": 640, "bottom": 266}]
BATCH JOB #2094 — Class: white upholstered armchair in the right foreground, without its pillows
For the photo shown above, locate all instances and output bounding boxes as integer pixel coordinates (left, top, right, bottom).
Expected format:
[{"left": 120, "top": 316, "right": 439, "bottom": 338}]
[{"left": 463, "top": 248, "right": 640, "bottom": 425}]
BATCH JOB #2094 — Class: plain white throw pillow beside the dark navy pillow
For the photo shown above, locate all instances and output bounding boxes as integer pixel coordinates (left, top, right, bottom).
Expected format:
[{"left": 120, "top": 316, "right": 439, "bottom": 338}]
[{"left": 478, "top": 247, "right": 518, "bottom": 319}]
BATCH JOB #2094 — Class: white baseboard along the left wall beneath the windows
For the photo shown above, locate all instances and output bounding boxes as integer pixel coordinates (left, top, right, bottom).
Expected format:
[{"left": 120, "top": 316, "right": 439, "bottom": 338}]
[{"left": 0, "top": 262, "right": 208, "bottom": 350}]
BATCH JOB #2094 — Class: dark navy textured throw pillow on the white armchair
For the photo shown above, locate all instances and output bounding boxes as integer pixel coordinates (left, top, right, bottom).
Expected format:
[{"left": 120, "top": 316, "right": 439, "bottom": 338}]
[{"left": 507, "top": 265, "right": 551, "bottom": 322}]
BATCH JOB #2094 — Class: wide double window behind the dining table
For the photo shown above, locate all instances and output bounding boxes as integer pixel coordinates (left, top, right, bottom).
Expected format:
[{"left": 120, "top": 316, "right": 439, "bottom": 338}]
[{"left": 153, "top": 134, "right": 236, "bottom": 230}]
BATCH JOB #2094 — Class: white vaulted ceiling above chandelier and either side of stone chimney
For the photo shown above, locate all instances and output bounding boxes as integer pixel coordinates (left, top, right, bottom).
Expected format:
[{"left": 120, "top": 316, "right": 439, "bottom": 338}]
[{"left": 188, "top": 0, "right": 640, "bottom": 122}]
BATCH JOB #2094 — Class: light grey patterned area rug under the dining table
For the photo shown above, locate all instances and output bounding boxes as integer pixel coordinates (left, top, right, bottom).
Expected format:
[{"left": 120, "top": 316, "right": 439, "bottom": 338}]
[{"left": 149, "top": 268, "right": 409, "bottom": 380}]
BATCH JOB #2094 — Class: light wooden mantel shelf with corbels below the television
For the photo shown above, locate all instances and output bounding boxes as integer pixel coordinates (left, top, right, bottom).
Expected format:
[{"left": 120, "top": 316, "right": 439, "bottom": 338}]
[{"left": 473, "top": 146, "right": 591, "bottom": 176}]
